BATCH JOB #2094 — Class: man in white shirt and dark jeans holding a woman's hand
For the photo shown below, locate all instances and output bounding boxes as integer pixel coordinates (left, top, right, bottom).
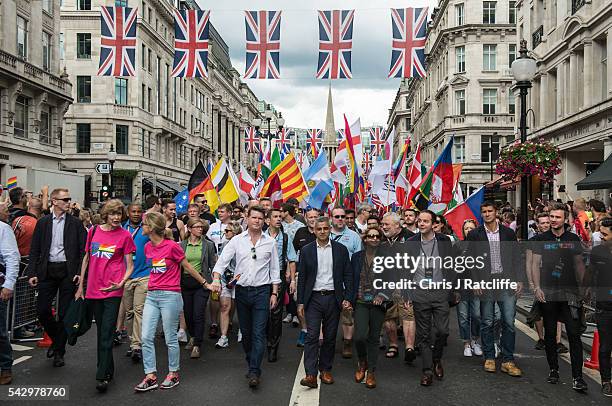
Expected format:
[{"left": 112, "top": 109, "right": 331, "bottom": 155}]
[{"left": 213, "top": 206, "right": 281, "bottom": 388}]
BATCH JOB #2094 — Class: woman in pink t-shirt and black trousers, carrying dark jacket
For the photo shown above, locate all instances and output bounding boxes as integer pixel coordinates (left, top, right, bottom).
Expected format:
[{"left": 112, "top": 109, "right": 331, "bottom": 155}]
[{"left": 75, "top": 199, "right": 136, "bottom": 392}]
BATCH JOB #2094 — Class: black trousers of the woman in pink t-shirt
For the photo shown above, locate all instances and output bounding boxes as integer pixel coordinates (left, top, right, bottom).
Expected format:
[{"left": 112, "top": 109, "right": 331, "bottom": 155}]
[{"left": 88, "top": 297, "right": 121, "bottom": 380}]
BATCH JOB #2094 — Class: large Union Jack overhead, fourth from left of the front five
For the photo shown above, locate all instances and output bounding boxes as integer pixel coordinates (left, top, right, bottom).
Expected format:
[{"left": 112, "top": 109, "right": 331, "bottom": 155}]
[{"left": 316, "top": 10, "right": 355, "bottom": 79}]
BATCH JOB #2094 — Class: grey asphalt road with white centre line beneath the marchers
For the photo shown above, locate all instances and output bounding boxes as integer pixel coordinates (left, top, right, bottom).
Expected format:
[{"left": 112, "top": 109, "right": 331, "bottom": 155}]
[{"left": 0, "top": 310, "right": 612, "bottom": 406}]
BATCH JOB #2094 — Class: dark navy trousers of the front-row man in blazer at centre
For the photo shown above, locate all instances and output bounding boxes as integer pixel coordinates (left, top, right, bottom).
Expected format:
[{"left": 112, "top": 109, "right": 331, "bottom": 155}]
[{"left": 304, "top": 292, "right": 340, "bottom": 375}]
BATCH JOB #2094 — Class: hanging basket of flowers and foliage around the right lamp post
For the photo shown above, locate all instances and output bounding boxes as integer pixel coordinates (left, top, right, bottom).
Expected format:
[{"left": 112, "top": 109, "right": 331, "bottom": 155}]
[{"left": 495, "top": 142, "right": 561, "bottom": 183}]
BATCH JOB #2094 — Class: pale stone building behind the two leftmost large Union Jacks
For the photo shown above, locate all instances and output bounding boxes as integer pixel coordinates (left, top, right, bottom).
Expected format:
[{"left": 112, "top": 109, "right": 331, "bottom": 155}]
[{"left": 60, "top": 0, "right": 259, "bottom": 201}]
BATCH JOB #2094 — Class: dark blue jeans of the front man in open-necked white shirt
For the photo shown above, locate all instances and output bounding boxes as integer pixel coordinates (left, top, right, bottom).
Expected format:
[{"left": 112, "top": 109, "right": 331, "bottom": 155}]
[{"left": 235, "top": 285, "right": 270, "bottom": 376}]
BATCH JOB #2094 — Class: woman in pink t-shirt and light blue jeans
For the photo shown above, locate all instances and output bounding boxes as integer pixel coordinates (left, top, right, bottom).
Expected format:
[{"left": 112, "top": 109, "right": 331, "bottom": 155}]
[{"left": 134, "top": 213, "right": 221, "bottom": 392}]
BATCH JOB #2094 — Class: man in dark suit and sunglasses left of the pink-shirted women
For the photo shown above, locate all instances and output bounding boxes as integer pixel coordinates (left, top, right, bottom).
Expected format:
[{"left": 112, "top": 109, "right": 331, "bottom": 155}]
[{"left": 27, "top": 188, "right": 87, "bottom": 367}]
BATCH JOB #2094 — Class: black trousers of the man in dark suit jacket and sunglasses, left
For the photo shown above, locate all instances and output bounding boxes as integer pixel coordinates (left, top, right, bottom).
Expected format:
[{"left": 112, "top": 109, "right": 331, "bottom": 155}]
[{"left": 36, "top": 270, "right": 77, "bottom": 355}]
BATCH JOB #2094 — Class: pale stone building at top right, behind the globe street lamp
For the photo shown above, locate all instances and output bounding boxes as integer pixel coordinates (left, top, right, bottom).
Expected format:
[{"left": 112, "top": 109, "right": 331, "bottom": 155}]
[{"left": 517, "top": 0, "right": 612, "bottom": 203}]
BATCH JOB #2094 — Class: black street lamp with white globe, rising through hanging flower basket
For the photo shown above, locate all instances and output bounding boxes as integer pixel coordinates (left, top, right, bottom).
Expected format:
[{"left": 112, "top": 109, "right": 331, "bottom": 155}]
[{"left": 510, "top": 40, "right": 538, "bottom": 241}]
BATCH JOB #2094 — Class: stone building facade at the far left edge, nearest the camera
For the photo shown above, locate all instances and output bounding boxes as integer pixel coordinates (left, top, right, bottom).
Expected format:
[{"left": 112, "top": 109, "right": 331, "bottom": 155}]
[{"left": 0, "top": 0, "right": 77, "bottom": 197}]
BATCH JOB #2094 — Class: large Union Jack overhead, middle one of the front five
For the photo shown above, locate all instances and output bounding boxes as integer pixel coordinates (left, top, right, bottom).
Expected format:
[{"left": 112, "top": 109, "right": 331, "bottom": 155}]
[{"left": 244, "top": 11, "right": 281, "bottom": 79}]
